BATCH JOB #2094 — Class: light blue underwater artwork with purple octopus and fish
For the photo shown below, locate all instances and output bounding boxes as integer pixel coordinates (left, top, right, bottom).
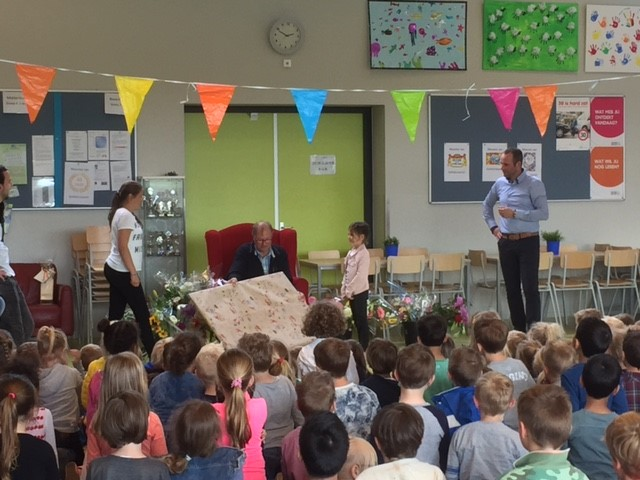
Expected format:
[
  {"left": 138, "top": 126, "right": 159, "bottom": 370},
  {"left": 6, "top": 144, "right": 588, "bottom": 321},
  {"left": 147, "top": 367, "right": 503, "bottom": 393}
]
[{"left": 369, "top": 0, "right": 467, "bottom": 70}]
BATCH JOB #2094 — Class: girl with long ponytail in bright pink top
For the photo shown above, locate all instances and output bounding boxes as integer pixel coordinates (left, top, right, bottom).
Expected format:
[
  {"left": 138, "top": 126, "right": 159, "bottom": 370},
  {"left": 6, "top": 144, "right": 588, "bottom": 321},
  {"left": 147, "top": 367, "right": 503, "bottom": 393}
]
[{"left": 213, "top": 348, "right": 267, "bottom": 480}]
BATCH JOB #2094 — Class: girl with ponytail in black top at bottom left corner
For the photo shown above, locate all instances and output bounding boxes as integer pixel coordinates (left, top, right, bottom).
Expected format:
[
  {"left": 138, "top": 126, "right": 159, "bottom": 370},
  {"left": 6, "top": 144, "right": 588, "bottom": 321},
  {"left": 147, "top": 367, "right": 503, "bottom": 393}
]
[{"left": 0, "top": 374, "right": 59, "bottom": 480}]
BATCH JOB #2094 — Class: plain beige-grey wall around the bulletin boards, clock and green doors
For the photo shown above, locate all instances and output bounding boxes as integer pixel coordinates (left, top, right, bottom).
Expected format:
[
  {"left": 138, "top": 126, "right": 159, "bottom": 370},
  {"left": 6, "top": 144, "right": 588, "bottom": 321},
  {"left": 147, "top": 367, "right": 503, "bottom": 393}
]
[{"left": 0, "top": 0, "right": 640, "bottom": 280}]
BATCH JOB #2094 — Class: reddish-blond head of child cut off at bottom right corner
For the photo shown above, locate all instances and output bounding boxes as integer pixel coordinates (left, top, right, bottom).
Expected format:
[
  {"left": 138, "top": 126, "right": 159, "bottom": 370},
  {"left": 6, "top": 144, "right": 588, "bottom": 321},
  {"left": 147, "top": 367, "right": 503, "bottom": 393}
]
[{"left": 604, "top": 412, "right": 640, "bottom": 478}]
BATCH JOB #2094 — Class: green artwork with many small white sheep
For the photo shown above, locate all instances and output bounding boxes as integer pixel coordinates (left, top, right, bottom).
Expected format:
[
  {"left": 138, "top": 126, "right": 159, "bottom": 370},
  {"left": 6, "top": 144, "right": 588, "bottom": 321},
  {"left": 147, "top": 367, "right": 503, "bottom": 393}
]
[{"left": 482, "top": 0, "right": 579, "bottom": 72}]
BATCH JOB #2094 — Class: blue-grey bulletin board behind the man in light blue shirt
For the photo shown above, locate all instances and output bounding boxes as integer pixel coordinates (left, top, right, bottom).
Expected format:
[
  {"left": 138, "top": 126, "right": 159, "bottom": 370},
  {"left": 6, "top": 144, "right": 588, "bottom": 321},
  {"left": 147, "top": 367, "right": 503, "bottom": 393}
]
[{"left": 428, "top": 95, "right": 624, "bottom": 203}]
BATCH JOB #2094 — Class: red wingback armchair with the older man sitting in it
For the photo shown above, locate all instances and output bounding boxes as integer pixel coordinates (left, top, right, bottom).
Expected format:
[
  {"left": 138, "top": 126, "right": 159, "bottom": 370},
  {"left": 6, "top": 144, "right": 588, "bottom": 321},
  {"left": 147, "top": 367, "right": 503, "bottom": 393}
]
[{"left": 204, "top": 223, "right": 309, "bottom": 297}]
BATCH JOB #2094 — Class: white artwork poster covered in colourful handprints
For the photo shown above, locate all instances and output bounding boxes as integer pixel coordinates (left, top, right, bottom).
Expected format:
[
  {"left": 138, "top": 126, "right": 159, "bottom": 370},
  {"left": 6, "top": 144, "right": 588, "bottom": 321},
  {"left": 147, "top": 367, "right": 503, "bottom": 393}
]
[{"left": 584, "top": 5, "right": 640, "bottom": 73}]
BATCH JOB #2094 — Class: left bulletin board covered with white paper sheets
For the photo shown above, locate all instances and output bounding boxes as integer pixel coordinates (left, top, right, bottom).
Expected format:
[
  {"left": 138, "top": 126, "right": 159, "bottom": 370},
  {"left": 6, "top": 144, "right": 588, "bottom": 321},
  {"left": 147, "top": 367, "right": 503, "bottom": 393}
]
[{"left": 0, "top": 91, "right": 136, "bottom": 209}]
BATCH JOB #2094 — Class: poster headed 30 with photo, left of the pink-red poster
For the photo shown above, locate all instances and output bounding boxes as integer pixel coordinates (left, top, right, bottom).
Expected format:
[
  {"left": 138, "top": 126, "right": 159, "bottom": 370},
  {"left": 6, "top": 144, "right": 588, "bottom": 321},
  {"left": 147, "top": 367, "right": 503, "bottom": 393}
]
[{"left": 556, "top": 97, "right": 591, "bottom": 151}]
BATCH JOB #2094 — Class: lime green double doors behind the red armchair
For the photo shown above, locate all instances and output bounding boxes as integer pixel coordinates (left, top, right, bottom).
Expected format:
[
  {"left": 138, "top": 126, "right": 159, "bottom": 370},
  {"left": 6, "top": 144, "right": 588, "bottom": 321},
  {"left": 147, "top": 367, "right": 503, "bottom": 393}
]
[{"left": 185, "top": 112, "right": 364, "bottom": 281}]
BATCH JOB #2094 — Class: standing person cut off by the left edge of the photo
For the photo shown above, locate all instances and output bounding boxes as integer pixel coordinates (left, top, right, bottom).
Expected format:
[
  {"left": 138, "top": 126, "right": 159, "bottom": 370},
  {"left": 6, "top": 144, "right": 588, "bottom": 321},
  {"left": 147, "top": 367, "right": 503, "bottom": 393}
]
[{"left": 0, "top": 165, "right": 34, "bottom": 345}]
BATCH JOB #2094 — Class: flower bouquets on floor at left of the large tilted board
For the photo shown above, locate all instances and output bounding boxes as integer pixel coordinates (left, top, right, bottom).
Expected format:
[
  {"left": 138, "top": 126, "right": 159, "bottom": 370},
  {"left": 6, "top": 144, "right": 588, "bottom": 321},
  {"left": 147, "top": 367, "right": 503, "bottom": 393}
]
[{"left": 149, "top": 272, "right": 217, "bottom": 342}]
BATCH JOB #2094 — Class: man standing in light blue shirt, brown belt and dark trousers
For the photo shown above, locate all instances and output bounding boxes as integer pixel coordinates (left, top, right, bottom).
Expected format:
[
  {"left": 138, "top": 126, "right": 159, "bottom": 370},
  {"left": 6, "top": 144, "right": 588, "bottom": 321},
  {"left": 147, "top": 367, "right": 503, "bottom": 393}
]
[{"left": 482, "top": 148, "right": 549, "bottom": 332}]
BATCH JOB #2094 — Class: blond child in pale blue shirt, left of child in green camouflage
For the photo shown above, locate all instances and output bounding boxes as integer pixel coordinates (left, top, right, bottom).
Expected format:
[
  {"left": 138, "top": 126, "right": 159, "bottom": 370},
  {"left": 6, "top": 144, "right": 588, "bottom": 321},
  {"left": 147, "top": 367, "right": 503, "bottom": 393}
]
[{"left": 446, "top": 372, "right": 527, "bottom": 480}]
